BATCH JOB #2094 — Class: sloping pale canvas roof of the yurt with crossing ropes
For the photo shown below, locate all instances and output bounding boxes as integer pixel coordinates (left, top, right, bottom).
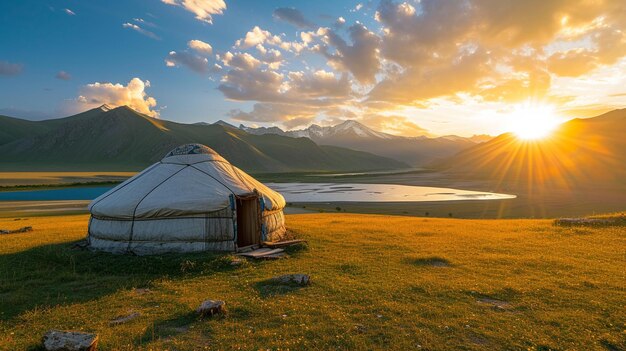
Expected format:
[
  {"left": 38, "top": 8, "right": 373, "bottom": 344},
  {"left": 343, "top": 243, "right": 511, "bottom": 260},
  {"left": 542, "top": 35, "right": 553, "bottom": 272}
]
[{"left": 89, "top": 144, "right": 285, "bottom": 219}]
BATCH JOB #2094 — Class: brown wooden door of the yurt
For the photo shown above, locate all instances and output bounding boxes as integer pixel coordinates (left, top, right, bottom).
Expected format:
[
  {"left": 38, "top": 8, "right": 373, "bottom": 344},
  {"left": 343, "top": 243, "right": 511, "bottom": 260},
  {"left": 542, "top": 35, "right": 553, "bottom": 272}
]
[{"left": 237, "top": 194, "right": 261, "bottom": 247}]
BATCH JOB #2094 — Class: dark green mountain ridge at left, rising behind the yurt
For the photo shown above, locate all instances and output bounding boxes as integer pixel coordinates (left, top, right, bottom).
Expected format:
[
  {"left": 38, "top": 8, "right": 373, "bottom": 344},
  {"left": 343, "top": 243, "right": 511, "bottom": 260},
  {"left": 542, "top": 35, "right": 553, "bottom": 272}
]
[{"left": 0, "top": 106, "right": 408, "bottom": 172}]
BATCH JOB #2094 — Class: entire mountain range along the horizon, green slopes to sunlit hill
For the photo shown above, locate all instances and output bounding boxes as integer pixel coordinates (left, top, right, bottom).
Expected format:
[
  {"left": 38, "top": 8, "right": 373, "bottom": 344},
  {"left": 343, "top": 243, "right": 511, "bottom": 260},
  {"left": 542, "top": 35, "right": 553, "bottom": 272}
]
[{"left": 0, "top": 105, "right": 626, "bottom": 188}]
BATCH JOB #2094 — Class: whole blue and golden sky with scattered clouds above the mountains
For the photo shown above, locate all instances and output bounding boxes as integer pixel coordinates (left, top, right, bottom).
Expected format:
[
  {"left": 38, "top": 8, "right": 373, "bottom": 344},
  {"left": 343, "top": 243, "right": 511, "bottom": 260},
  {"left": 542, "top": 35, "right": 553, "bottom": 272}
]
[{"left": 0, "top": 0, "right": 626, "bottom": 136}]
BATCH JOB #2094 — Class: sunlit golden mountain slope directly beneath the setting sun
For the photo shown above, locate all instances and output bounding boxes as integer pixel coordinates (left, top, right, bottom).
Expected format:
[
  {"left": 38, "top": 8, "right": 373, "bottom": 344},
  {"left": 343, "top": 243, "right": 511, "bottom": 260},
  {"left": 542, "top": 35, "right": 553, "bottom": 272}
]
[{"left": 433, "top": 109, "right": 626, "bottom": 188}]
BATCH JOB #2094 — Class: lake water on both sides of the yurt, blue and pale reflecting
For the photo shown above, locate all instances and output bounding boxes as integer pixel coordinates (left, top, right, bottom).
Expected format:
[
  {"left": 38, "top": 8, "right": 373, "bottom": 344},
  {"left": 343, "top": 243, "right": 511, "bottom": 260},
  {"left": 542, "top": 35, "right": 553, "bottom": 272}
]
[{"left": 0, "top": 183, "right": 515, "bottom": 202}]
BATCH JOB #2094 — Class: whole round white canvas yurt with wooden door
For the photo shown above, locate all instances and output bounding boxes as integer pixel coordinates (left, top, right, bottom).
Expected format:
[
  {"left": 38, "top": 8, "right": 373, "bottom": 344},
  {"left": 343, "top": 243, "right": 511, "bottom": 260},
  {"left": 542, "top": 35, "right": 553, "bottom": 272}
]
[{"left": 87, "top": 144, "right": 285, "bottom": 255}]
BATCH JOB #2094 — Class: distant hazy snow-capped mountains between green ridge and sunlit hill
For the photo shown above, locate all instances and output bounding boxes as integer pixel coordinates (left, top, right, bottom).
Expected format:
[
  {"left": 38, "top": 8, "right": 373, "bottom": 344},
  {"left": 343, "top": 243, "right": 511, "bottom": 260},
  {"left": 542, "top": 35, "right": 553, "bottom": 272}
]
[{"left": 239, "top": 120, "right": 482, "bottom": 166}]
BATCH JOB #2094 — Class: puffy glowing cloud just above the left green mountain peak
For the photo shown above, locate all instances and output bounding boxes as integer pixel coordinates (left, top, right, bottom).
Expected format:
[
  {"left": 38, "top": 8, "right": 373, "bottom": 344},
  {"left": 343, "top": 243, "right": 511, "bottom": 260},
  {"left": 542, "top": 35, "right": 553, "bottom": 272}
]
[{"left": 75, "top": 78, "right": 159, "bottom": 118}]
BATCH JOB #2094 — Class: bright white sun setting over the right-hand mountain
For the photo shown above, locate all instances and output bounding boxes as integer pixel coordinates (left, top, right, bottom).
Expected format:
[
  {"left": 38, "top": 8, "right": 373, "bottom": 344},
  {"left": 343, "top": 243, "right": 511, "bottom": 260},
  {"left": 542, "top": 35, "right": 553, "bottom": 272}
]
[{"left": 507, "top": 103, "right": 561, "bottom": 140}]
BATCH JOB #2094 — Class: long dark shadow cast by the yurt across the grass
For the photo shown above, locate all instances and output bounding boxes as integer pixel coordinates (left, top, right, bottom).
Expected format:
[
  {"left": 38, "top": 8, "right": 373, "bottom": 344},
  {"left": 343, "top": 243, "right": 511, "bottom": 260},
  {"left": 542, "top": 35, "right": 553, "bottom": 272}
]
[{"left": 0, "top": 242, "right": 236, "bottom": 321}]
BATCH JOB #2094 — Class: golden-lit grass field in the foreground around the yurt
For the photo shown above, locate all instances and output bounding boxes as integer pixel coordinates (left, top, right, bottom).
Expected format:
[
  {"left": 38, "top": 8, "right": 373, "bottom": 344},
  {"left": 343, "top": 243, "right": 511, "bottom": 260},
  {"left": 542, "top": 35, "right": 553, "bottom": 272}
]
[{"left": 0, "top": 214, "right": 626, "bottom": 350}]
